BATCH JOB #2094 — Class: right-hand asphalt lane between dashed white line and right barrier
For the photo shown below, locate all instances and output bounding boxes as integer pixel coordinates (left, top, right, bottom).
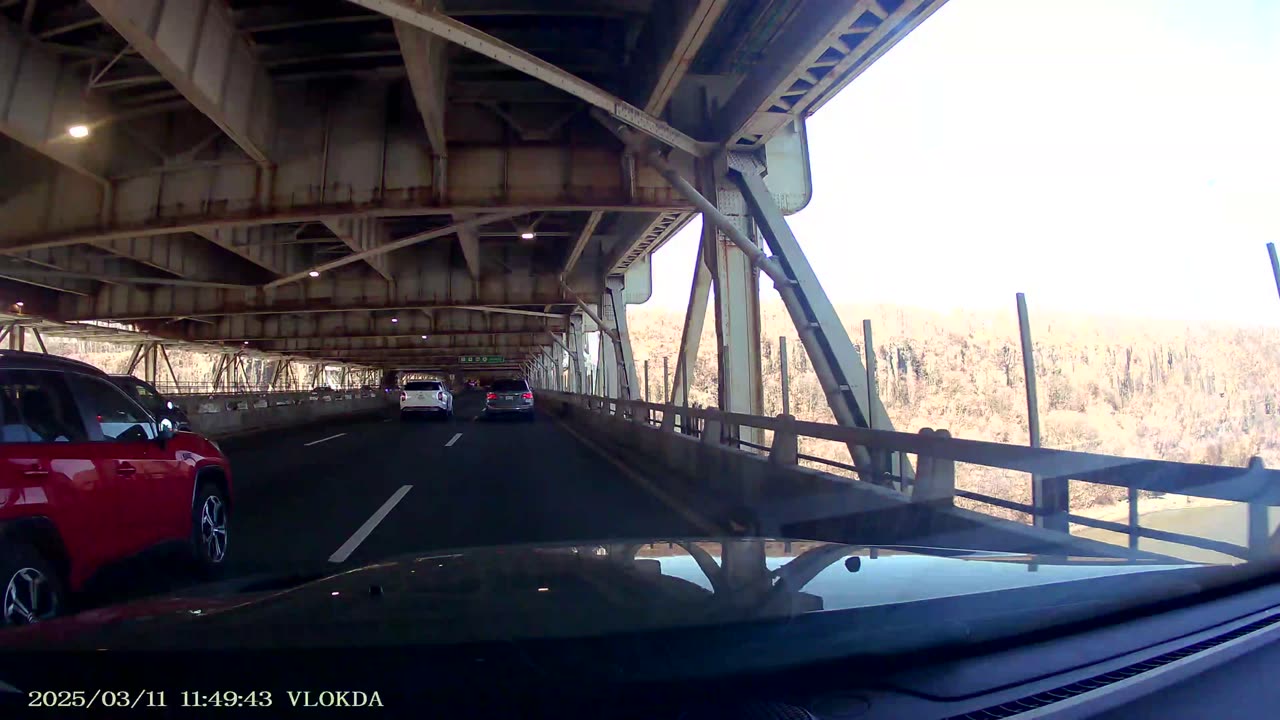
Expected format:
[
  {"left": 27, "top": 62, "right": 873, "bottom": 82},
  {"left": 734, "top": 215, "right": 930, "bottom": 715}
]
[{"left": 348, "top": 397, "right": 705, "bottom": 564}]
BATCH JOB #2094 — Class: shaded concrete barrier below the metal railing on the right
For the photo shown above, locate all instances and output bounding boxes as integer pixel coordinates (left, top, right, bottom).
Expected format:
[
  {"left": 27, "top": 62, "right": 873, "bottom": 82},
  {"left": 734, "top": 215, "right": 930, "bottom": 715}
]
[{"left": 539, "top": 393, "right": 1152, "bottom": 557}]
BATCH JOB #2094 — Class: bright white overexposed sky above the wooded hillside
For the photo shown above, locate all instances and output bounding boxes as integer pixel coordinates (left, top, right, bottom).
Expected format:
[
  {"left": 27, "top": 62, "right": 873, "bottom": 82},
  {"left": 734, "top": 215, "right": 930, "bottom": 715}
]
[{"left": 650, "top": 0, "right": 1280, "bottom": 325}]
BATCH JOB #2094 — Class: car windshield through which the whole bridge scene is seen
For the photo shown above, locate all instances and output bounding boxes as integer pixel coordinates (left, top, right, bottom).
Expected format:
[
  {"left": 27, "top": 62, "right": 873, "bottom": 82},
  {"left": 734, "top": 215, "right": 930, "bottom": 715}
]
[{"left": 0, "top": 0, "right": 1280, "bottom": 696}]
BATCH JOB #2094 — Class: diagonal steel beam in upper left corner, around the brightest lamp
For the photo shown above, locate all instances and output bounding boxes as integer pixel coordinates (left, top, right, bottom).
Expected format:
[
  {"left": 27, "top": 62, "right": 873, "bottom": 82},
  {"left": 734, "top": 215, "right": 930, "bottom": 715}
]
[{"left": 0, "top": 18, "right": 110, "bottom": 183}]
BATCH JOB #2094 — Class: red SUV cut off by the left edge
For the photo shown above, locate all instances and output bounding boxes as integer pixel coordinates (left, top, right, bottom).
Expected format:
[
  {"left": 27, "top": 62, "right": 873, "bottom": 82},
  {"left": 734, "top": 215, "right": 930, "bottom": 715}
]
[{"left": 0, "top": 351, "right": 232, "bottom": 626}]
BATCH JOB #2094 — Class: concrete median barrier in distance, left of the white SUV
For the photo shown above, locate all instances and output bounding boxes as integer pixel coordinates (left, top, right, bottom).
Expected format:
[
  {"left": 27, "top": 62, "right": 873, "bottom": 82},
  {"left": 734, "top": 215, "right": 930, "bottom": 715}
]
[{"left": 188, "top": 393, "right": 394, "bottom": 439}]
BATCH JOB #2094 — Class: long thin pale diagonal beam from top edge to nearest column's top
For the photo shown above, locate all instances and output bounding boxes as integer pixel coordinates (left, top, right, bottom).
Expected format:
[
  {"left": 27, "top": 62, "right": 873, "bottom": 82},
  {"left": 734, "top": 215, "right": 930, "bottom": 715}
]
[{"left": 348, "top": 0, "right": 710, "bottom": 156}]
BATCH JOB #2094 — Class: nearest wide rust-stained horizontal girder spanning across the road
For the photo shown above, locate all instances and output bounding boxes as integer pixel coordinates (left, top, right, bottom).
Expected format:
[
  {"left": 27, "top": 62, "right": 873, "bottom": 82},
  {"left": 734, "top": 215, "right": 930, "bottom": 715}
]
[{"left": 0, "top": 109, "right": 689, "bottom": 249}]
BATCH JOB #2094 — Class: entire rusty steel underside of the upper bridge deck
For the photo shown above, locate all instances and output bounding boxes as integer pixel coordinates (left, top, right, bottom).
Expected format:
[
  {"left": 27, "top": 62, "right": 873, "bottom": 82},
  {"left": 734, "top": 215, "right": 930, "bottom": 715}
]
[{"left": 0, "top": 0, "right": 941, "bottom": 369}]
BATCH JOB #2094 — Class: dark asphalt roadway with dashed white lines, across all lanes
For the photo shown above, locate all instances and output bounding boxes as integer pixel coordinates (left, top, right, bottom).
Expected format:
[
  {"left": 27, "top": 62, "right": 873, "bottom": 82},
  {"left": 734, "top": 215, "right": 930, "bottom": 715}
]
[{"left": 82, "top": 392, "right": 704, "bottom": 606}]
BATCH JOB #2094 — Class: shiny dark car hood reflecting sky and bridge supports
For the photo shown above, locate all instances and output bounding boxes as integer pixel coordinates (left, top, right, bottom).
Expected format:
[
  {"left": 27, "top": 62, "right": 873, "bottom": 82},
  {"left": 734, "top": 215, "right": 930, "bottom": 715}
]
[{"left": 0, "top": 538, "right": 1197, "bottom": 650}]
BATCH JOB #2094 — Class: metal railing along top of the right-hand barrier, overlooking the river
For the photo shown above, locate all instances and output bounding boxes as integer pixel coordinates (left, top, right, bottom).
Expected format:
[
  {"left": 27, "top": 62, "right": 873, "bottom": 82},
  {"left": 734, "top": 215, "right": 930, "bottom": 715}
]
[{"left": 538, "top": 389, "right": 1280, "bottom": 560}]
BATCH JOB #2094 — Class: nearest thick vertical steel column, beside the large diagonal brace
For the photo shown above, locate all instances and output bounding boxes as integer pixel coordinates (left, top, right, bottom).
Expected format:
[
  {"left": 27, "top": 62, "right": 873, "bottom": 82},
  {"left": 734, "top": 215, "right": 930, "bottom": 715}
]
[{"left": 698, "top": 158, "right": 764, "bottom": 443}]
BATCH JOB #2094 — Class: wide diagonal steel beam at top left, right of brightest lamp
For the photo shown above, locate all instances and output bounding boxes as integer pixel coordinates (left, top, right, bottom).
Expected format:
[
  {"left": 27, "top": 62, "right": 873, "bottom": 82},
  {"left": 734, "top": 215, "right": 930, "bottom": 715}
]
[{"left": 88, "top": 0, "right": 275, "bottom": 165}]
